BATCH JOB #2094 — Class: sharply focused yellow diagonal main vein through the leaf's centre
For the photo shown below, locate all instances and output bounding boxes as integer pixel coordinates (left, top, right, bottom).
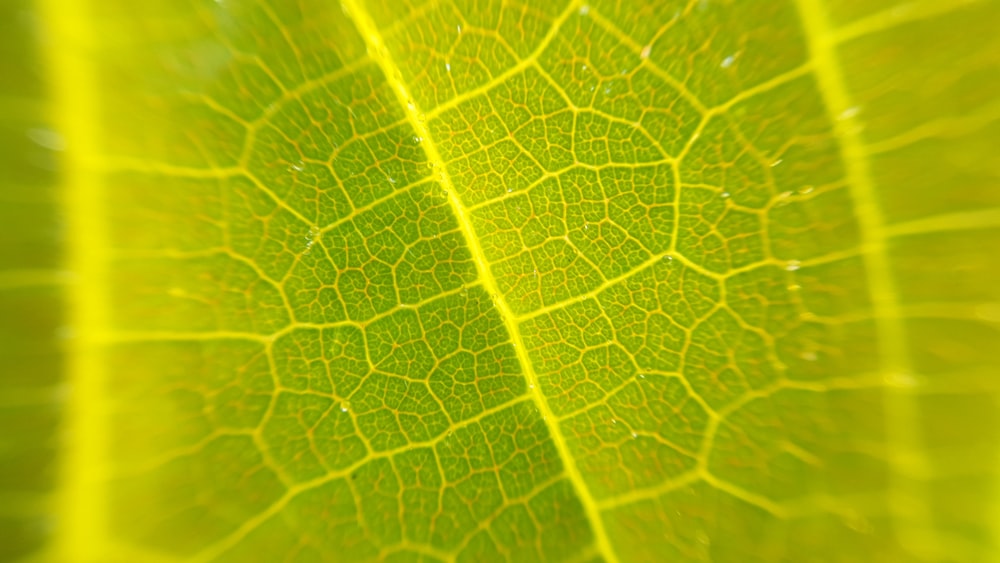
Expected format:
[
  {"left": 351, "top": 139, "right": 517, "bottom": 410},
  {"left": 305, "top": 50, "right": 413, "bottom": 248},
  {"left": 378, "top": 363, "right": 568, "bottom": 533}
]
[{"left": 343, "top": 0, "right": 618, "bottom": 563}]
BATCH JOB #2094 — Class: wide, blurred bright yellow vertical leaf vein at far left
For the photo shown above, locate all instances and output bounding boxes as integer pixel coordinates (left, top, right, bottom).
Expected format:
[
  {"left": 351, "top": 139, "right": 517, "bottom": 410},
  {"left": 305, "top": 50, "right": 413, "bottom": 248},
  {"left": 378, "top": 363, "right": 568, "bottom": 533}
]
[{"left": 39, "top": 0, "right": 107, "bottom": 562}]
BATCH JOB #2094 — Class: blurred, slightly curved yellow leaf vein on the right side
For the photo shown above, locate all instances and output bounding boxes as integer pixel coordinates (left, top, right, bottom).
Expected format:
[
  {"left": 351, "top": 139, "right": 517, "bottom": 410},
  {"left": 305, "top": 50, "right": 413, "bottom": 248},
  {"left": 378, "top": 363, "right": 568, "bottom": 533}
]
[{"left": 796, "top": 0, "right": 942, "bottom": 555}]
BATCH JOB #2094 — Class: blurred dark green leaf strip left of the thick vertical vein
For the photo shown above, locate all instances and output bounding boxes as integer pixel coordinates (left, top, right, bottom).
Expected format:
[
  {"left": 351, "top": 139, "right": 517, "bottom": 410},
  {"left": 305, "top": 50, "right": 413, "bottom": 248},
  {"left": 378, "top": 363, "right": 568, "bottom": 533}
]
[{"left": 0, "top": 0, "right": 64, "bottom": 561}]
